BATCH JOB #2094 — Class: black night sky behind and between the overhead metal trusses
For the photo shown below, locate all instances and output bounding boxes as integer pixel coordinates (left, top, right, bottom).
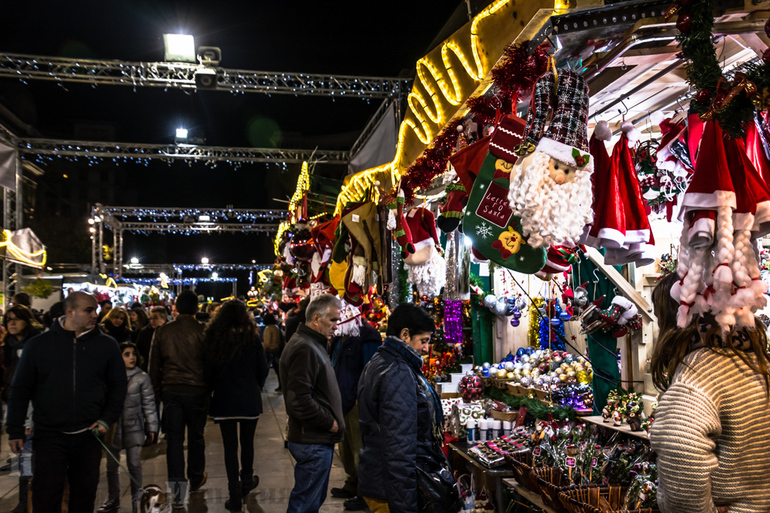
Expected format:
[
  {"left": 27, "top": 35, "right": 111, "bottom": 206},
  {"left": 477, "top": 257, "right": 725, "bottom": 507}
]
[{"left": 0, "top": 0, "right": 472, "bottom": 270}]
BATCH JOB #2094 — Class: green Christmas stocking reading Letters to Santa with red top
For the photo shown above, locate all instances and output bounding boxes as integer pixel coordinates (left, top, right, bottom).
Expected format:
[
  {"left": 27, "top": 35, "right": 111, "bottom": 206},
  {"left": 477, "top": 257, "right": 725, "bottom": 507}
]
[{"left": 463, "top": 116, "right": 546, "bottom": 274}]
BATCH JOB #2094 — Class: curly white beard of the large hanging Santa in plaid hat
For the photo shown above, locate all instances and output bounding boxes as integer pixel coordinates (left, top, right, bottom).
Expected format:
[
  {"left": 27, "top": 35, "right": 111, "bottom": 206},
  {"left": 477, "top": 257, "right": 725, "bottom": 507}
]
[{"left": 508, "top": 152, "right": 593, "bottom": 248}]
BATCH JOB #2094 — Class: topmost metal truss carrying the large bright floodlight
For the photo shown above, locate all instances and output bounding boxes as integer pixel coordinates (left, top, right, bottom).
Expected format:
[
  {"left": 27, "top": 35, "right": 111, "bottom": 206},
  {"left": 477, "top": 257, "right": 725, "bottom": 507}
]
[{"left": 0, "top": 53, "right": 411, "bottom": 98}]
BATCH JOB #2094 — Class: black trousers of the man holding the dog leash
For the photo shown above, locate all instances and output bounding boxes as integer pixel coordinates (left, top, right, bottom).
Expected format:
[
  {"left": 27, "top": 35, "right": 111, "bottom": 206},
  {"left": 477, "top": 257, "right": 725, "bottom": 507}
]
[{"left": 32, "top": 431, "right": 102, "bottom": 513}]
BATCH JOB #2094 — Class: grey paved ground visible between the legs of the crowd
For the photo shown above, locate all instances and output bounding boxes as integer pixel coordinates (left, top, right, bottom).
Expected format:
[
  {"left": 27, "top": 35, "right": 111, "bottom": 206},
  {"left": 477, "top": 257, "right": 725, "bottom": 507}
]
[{"left": 0, "top": 371, "right": 356, "bottom": 513}]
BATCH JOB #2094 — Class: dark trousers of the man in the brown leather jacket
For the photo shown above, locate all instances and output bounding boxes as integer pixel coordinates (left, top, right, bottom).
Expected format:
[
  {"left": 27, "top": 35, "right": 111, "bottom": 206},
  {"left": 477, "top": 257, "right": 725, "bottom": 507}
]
[{"left": 163, "top": 392, "right": 209, "bottom": 487}]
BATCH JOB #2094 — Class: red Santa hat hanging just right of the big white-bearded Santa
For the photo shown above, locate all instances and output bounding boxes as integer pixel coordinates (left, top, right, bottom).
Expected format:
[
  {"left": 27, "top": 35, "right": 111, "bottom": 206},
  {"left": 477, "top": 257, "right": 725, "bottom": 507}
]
[{"left": 585, "top": 121, "right": 626, "bottom": 249}]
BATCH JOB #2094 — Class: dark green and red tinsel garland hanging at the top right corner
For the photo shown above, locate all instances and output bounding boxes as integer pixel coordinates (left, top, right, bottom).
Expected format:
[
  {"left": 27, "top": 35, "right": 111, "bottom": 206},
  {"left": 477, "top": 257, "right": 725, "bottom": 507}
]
[{"left": 670, "top": 0, "right": 770, "bottom": 139}]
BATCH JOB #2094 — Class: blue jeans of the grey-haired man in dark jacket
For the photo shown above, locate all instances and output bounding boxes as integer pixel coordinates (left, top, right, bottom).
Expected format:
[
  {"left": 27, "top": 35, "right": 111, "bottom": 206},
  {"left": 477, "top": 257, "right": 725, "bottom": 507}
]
[{"left": 286, "top": 442, "right": 334, "bottom": 513}]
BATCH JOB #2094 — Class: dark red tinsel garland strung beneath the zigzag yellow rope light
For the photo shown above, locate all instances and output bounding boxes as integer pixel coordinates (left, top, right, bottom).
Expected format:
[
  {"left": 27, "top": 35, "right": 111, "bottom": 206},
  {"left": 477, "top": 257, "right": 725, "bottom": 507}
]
[{"left": 401, "top": 41, "right": 549, "bottom": 201}]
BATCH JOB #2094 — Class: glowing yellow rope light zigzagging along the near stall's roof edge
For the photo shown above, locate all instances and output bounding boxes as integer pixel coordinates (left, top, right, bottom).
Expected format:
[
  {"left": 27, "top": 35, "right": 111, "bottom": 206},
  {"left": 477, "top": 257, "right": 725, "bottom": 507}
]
[{"left": 335, "top": 0, "right": 508, "bottom": 214}]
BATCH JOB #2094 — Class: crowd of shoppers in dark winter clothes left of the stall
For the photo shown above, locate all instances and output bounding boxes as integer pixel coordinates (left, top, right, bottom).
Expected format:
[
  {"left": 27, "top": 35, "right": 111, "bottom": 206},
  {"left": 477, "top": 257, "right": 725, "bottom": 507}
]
[{"left": 1, "top": 291, "right": 452, "bottom": 513}]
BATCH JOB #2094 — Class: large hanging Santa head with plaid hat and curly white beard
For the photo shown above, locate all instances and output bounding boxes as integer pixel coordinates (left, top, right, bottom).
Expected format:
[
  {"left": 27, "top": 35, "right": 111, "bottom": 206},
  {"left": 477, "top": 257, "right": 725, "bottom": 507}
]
[{"left": 508, "top": 70, "right": 594, "bottom": 248}]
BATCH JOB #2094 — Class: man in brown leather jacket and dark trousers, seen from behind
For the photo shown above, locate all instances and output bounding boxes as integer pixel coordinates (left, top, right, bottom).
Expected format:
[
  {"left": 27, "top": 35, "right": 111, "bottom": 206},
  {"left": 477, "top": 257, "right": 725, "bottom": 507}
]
[{"left": 149, "top": 290, "right": 209, "bottom": 508}]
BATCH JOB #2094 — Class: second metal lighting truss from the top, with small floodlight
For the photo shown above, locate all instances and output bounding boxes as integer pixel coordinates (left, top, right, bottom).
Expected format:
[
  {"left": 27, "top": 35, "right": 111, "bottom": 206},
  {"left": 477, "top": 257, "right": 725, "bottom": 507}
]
[{"left": 18, "top": 139, "right": 350, "bottom": 165}]
